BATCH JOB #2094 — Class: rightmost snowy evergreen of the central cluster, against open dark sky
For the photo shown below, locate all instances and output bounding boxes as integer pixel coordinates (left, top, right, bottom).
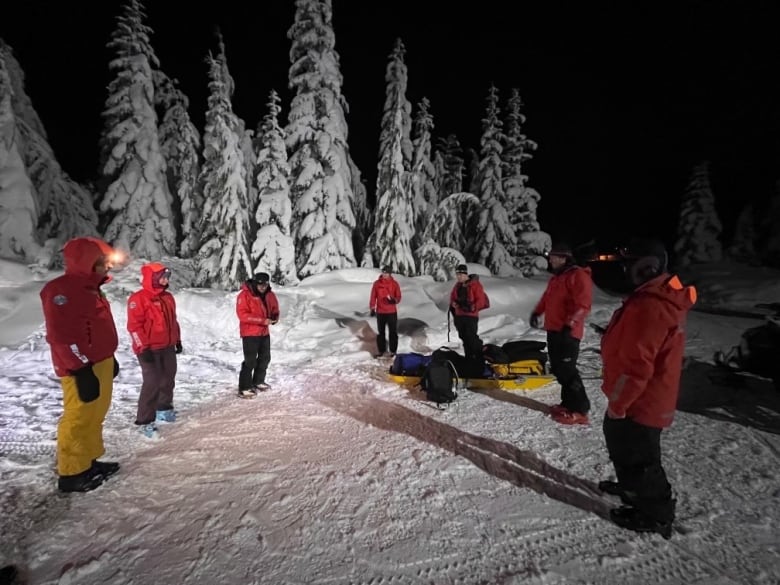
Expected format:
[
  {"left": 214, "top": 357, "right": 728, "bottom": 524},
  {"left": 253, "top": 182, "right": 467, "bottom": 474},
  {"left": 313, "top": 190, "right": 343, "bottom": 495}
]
[{"left": 502, "top": 88, "right": 551, "bottom": 276}]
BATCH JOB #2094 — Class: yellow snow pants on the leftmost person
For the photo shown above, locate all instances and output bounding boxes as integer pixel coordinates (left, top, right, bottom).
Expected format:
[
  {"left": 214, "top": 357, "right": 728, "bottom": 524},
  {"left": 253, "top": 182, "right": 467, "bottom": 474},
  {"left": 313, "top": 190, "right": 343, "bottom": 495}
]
[{"left": 57, "top": 356, "right": 114, "bottom": 475}]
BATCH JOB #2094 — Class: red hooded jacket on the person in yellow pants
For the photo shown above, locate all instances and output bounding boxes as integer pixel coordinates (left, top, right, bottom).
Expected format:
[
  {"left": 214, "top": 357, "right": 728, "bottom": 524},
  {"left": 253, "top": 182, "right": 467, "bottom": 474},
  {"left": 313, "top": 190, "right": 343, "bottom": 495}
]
[{"left": 41, "top": 237, "right": 118, "bottom": 376}]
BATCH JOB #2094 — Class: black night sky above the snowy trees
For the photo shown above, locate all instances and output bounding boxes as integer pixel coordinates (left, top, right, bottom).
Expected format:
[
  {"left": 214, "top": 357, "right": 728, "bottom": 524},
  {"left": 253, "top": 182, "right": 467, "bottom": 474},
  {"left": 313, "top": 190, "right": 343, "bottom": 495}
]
[{"left": 0, "top": 0, "right": 780, "bottom": 248}]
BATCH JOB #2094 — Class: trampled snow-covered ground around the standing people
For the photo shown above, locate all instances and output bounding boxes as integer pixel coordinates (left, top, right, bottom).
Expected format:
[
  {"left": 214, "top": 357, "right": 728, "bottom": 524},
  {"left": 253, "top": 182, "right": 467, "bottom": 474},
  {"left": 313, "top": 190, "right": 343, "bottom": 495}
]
[{"left": 0, "top": 261, "right": 780, "bottom": 585}]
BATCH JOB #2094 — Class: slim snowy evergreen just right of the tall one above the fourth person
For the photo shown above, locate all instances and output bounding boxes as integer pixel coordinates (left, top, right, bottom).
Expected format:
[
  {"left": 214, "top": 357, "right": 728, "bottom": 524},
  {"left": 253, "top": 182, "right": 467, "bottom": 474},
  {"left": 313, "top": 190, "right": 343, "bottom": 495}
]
[{"left": 408, "top": 98, "right": 438, "bottom": 251}]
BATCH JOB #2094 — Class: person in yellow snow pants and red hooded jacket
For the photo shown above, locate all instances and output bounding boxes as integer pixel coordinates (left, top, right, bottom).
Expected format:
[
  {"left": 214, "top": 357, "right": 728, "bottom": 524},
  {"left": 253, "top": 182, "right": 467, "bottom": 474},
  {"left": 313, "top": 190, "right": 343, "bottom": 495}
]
[{"left": 40, "top": 237, "right": 119, "bottom": 492}]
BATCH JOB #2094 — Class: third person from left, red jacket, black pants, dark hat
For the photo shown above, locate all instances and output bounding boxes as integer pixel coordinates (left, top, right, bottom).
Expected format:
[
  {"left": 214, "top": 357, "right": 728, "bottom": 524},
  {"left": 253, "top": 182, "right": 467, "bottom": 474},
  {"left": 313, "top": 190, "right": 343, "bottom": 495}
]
[{"left": 236, "top": 272, "right": 279, "bottom": 397}]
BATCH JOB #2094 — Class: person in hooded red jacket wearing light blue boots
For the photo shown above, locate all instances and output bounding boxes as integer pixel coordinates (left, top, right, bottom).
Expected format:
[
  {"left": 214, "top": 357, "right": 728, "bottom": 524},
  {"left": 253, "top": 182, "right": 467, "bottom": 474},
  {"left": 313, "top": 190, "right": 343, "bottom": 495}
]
[{"left": 127, "top": 262, "right": 182, "bottom": 438}]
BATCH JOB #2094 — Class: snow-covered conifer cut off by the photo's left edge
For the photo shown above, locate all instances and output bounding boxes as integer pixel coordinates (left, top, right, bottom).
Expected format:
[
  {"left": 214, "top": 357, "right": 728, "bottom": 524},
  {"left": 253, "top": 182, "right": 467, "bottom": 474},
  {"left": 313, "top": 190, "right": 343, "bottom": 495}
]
[{"left": 0, "top": 54, "right": 41, "bottom": 262}]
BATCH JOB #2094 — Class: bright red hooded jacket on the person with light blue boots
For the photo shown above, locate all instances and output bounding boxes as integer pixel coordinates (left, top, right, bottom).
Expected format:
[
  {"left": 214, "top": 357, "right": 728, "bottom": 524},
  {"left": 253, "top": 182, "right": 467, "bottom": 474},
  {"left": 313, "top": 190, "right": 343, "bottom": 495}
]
[{"left": 127, "top": 262, "right": 181, "bottom": 355}]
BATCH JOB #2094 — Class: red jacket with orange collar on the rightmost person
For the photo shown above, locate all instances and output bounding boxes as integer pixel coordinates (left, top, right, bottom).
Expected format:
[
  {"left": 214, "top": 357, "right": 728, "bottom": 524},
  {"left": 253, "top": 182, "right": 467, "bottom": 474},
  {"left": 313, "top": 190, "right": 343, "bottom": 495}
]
[{"left": 601, "top": 274, "right": 696, "bottom": 428}]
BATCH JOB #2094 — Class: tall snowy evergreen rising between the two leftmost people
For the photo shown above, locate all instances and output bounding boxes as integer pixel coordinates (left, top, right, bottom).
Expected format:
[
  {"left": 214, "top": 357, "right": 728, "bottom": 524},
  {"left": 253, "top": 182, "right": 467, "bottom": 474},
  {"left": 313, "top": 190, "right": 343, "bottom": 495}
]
[{"left": 100, "top": 0, "right": 176, "bottom": 258}]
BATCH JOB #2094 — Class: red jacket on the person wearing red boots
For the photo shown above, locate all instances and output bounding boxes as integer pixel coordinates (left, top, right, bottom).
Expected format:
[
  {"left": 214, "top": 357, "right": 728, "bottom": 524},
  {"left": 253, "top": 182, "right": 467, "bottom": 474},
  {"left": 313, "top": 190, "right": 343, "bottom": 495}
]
[{"left": 534, "top": 265, "right": 593, "bottom": 339}]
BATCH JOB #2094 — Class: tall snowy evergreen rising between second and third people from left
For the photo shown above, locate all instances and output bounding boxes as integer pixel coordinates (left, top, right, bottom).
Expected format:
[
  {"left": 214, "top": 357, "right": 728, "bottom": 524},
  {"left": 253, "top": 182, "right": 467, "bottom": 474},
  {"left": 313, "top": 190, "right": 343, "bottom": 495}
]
[{"left": 196, "top": 39, "right": 252, "bottom": 289}]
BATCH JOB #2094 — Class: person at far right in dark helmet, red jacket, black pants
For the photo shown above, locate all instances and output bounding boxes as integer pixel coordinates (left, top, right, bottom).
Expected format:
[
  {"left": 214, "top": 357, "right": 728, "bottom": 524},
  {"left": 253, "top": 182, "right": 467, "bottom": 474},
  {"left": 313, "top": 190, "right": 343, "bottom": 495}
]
[{"left": 599, "top": 240, "right": 696, "bottom": 539}]
